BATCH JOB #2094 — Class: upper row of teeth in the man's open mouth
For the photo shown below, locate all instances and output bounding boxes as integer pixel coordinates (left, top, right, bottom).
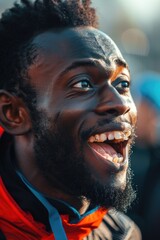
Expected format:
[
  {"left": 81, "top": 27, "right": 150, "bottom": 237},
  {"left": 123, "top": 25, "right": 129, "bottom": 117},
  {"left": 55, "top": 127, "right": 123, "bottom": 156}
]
[{"left": 88, "top": 130, "right": 131, "bottom": 143}]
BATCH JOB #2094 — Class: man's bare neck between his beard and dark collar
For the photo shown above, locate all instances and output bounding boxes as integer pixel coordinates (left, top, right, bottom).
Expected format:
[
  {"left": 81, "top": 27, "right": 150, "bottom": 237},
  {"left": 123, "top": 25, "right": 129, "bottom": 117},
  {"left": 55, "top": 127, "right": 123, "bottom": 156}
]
[{"left": 14, "top": 136, "right": 90, "bottom": 214}]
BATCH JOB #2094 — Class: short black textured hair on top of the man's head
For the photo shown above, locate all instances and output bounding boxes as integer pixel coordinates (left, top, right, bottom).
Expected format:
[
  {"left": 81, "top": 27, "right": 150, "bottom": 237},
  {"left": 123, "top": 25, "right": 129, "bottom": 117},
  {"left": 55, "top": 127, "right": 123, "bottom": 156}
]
[{"left": 0, "top": 0, "right": 97, "bottom": 94}]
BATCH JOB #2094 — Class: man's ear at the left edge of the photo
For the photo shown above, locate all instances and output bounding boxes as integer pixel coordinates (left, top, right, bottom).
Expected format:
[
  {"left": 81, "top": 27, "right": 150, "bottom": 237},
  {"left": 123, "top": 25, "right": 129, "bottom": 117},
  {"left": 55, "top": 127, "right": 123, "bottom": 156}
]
[{"left": 0, "top": 90, "right": 31, "bottom": 135}]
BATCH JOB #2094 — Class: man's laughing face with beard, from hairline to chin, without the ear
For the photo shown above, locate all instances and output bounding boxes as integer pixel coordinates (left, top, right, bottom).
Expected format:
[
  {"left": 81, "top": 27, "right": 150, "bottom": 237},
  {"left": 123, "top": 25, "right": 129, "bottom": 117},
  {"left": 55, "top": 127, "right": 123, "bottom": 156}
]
[{"left": 28, "top": 28, "right": 136, "bottom": 210}]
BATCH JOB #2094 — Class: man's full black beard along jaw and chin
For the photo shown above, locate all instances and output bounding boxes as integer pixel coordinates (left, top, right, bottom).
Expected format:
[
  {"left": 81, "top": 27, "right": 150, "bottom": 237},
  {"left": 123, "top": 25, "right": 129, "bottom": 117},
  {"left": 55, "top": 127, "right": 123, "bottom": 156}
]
[{"left": 31, "top": 112, "right": 136, "bottom": 211}]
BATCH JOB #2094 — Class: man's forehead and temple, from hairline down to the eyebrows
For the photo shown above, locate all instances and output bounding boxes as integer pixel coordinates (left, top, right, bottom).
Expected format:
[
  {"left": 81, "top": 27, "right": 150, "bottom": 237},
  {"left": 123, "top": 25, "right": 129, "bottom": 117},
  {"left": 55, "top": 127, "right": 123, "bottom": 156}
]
[{"left": 28, "top": 27, "right": 125, "bottom": 90}]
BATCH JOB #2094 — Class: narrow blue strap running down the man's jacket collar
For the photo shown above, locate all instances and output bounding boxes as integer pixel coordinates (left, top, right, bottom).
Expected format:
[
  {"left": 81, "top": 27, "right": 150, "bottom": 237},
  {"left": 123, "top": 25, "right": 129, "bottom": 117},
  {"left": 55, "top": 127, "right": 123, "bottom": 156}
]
[{"left": 17, "top": 171, "right": 67, "bottom": 240}]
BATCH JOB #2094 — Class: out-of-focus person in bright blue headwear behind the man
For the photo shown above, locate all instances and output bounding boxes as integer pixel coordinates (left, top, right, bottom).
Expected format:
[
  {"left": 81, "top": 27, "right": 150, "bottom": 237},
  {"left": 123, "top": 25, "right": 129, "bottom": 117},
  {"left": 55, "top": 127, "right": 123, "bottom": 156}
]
[{"left": 129, "top": 72, "right": 160, "bottom": 240}]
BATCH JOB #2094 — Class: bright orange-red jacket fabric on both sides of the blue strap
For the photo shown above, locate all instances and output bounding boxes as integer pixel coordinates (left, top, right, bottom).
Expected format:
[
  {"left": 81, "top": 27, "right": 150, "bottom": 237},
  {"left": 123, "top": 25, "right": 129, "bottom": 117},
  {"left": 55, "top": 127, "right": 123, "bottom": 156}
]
[{"left": 0, "top": 178, "right": 107, "bottom": 240}]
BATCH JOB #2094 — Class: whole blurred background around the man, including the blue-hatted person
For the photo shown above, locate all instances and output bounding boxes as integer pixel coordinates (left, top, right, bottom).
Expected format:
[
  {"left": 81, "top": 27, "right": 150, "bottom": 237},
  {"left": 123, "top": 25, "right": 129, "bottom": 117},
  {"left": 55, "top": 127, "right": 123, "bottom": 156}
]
[{"left": 0, "top": 0, "right": 160, "bottom": 240}]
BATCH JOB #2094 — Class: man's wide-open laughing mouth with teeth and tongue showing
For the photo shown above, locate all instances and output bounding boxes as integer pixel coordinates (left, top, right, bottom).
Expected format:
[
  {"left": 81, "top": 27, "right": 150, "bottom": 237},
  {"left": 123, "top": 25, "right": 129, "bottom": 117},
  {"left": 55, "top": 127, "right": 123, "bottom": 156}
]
[{"left": 88, "top": 130, "right": 131, "bottom": 166}]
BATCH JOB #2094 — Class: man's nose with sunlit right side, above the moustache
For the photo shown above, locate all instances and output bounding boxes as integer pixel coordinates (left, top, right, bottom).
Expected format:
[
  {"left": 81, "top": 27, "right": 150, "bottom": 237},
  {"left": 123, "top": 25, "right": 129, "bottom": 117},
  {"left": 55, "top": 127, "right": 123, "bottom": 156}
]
[{"left": 95, "top": 84, "right": 130, "bottom": 117}]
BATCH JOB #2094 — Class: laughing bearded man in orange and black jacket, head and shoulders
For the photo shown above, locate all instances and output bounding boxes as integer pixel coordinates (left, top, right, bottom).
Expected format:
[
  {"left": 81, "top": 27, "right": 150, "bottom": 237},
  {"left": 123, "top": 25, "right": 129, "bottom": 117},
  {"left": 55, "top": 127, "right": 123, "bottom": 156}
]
[{"left": 0, "top": 0, "right": 140, "bottom": 240}]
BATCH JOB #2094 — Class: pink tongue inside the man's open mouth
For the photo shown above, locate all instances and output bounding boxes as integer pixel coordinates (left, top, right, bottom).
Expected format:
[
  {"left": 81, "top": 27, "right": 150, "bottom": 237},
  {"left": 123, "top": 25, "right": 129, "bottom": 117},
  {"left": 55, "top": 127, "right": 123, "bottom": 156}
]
[{"left": 90, "top": 143, "right": 117, "bottom": 160}]
